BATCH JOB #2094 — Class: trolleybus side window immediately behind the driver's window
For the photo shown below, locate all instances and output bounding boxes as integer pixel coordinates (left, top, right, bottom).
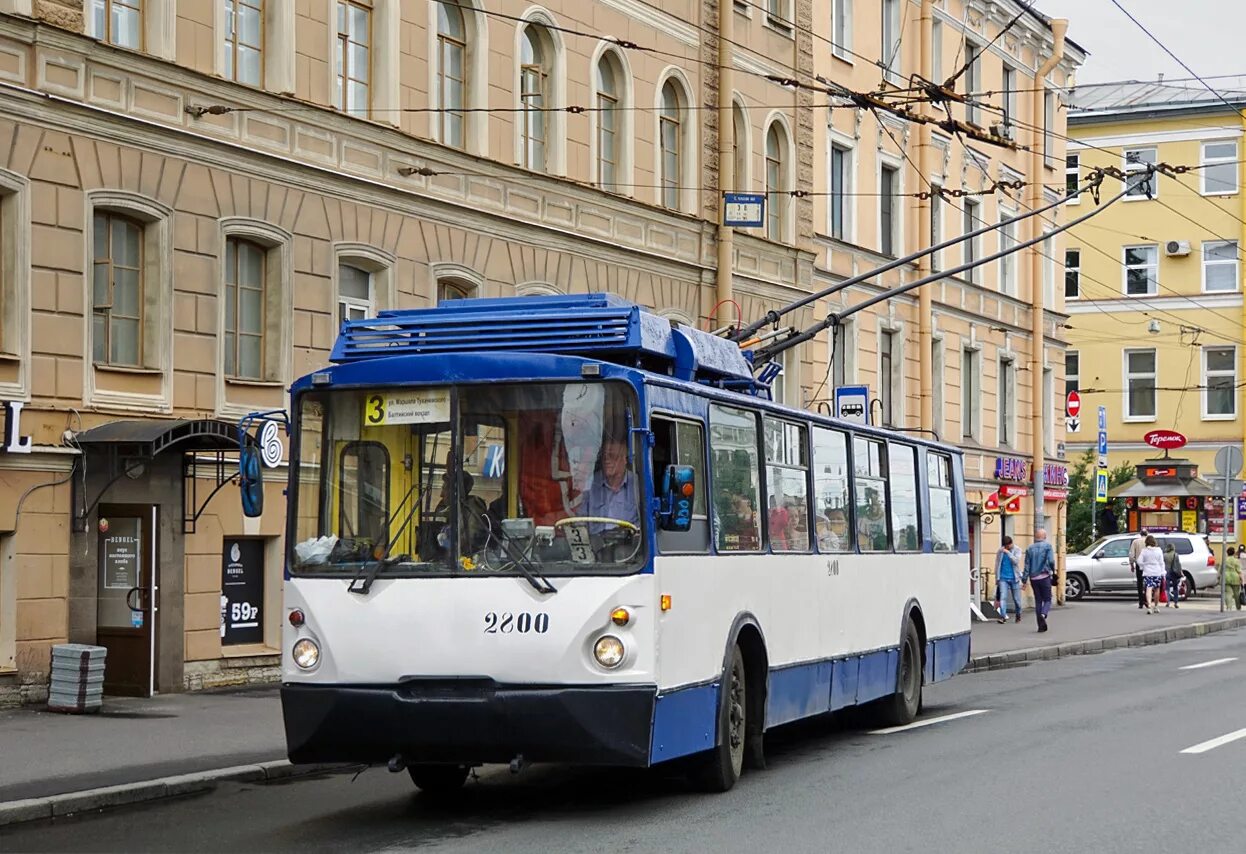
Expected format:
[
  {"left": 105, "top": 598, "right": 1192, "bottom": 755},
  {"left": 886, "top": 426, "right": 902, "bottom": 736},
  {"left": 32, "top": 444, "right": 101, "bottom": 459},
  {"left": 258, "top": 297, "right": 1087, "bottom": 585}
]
[{"left": 709, "top": 405, "right": 761, "bottom": 551}]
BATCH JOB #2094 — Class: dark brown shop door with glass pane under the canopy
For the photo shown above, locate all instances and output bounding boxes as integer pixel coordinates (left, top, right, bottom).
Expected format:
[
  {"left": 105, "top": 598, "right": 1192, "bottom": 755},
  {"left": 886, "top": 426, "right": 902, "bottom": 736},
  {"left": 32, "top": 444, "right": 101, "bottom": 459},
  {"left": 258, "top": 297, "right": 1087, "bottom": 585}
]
[{"left": 96, "top": 506, "right": 159, "bottom": 697}]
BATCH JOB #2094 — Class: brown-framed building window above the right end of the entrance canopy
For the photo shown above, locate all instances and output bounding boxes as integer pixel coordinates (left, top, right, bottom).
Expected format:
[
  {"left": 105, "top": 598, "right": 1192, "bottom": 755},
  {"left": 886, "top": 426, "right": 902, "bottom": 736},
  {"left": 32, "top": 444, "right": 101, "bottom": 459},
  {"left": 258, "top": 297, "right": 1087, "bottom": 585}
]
[{"left": 223, "top": 237, "right": 268, "bottom": 380}]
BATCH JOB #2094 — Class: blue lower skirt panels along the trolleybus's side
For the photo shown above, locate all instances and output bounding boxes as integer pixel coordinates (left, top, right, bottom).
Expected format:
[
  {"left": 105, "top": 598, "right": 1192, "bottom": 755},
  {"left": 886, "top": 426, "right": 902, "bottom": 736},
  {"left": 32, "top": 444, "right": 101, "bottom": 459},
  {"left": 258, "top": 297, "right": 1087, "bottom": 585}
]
[{"left": 649, "top": 632, "right": 969, "bottom": 764}]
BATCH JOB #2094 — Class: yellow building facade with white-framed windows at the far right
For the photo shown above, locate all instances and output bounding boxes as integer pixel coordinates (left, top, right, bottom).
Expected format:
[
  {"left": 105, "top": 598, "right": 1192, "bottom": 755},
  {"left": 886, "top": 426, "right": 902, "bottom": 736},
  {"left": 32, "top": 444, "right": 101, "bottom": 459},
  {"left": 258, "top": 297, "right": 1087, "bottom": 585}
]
[{"left": 1064, "top": 84, "right": 1246, "bottom": 539}]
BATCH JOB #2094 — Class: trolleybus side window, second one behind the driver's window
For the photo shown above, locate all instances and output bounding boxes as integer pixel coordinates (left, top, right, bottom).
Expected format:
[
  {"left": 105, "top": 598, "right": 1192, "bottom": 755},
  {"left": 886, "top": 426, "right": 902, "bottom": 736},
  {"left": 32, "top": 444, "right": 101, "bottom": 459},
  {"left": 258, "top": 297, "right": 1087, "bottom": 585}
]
[{"left": 765, "top": 418, "right": 809, "bottom": 551}]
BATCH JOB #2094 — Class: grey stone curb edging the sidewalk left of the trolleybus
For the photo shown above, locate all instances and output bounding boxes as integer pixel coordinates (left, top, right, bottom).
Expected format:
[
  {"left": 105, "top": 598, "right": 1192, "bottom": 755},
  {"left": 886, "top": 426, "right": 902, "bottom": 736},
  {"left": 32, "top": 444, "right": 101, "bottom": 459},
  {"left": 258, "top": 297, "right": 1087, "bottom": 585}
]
[{"left": 0, "top": 759, "right": 358, "bottom": 828}]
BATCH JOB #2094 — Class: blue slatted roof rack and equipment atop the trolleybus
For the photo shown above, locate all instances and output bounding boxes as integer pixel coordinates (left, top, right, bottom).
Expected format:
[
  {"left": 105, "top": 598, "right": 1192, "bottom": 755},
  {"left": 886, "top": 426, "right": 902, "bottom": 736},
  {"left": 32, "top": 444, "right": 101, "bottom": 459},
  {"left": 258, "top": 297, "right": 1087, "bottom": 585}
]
[{"left": 330, "top": 293, "right": 768, "bottom": 394}]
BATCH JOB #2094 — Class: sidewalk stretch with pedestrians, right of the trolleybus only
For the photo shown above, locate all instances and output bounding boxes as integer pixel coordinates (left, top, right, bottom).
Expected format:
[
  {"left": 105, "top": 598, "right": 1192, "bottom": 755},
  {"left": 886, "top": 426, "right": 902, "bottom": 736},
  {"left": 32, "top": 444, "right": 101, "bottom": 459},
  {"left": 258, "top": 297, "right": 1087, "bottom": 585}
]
[{"left": 969, "top": 596, "right": 1246, "bottom": 669}]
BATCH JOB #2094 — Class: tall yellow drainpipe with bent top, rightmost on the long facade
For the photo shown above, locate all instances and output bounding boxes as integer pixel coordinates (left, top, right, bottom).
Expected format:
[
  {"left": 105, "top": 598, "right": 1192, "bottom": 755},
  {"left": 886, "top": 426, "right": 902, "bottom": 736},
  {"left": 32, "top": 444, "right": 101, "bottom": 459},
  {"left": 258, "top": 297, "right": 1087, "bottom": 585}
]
[{"left": 1028, "top": 17, "right": 1069, "bottom": 593}]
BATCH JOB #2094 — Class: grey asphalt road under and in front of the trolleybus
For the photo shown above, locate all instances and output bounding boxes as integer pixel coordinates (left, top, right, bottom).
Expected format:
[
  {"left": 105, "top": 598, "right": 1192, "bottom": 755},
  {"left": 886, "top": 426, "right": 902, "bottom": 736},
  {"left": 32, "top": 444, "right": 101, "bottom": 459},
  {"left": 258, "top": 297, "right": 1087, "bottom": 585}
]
[{"left": 0, "top": 617, "right": 1246, "bottom": 854}]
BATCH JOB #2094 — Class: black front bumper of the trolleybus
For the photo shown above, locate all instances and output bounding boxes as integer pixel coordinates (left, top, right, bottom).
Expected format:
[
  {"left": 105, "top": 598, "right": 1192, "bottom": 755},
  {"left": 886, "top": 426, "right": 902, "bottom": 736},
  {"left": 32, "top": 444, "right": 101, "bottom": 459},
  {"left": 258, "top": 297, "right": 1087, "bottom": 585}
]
[{"left": 282, "top": 678, "right": 657, "bottom": 767}]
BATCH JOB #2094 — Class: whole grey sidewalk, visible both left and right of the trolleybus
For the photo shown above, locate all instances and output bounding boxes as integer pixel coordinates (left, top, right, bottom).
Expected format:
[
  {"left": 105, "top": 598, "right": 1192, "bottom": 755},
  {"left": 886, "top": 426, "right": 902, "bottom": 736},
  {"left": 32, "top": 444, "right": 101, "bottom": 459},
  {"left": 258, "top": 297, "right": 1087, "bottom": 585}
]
[{"left": 0, "top": 598, "right": 1246, "bottom": 827}]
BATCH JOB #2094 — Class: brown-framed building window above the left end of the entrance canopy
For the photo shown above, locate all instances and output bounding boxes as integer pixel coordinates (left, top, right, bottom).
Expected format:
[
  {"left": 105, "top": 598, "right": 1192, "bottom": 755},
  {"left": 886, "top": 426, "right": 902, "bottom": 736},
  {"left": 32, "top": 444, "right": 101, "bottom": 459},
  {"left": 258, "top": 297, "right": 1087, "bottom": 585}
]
[{"left": 91, "top": 212, "right": 145, "bottom": 368}]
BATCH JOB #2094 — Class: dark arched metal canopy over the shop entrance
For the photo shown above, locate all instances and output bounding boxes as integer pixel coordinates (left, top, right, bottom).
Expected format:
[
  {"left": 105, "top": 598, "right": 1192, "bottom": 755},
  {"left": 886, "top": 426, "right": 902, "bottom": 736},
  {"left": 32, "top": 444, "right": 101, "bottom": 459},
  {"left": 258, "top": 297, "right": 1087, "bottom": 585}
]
[{"left": 74, "top": 418, "right": 254, "bottom": 534}]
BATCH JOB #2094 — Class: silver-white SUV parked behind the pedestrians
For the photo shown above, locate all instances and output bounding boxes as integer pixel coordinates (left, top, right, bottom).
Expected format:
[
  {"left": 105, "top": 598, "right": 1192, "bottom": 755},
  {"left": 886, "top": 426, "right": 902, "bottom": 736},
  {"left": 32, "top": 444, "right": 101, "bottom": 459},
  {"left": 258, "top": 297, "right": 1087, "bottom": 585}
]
[{"left": 1064, "top": 534, "right": 1220, "bottom": 600}]
